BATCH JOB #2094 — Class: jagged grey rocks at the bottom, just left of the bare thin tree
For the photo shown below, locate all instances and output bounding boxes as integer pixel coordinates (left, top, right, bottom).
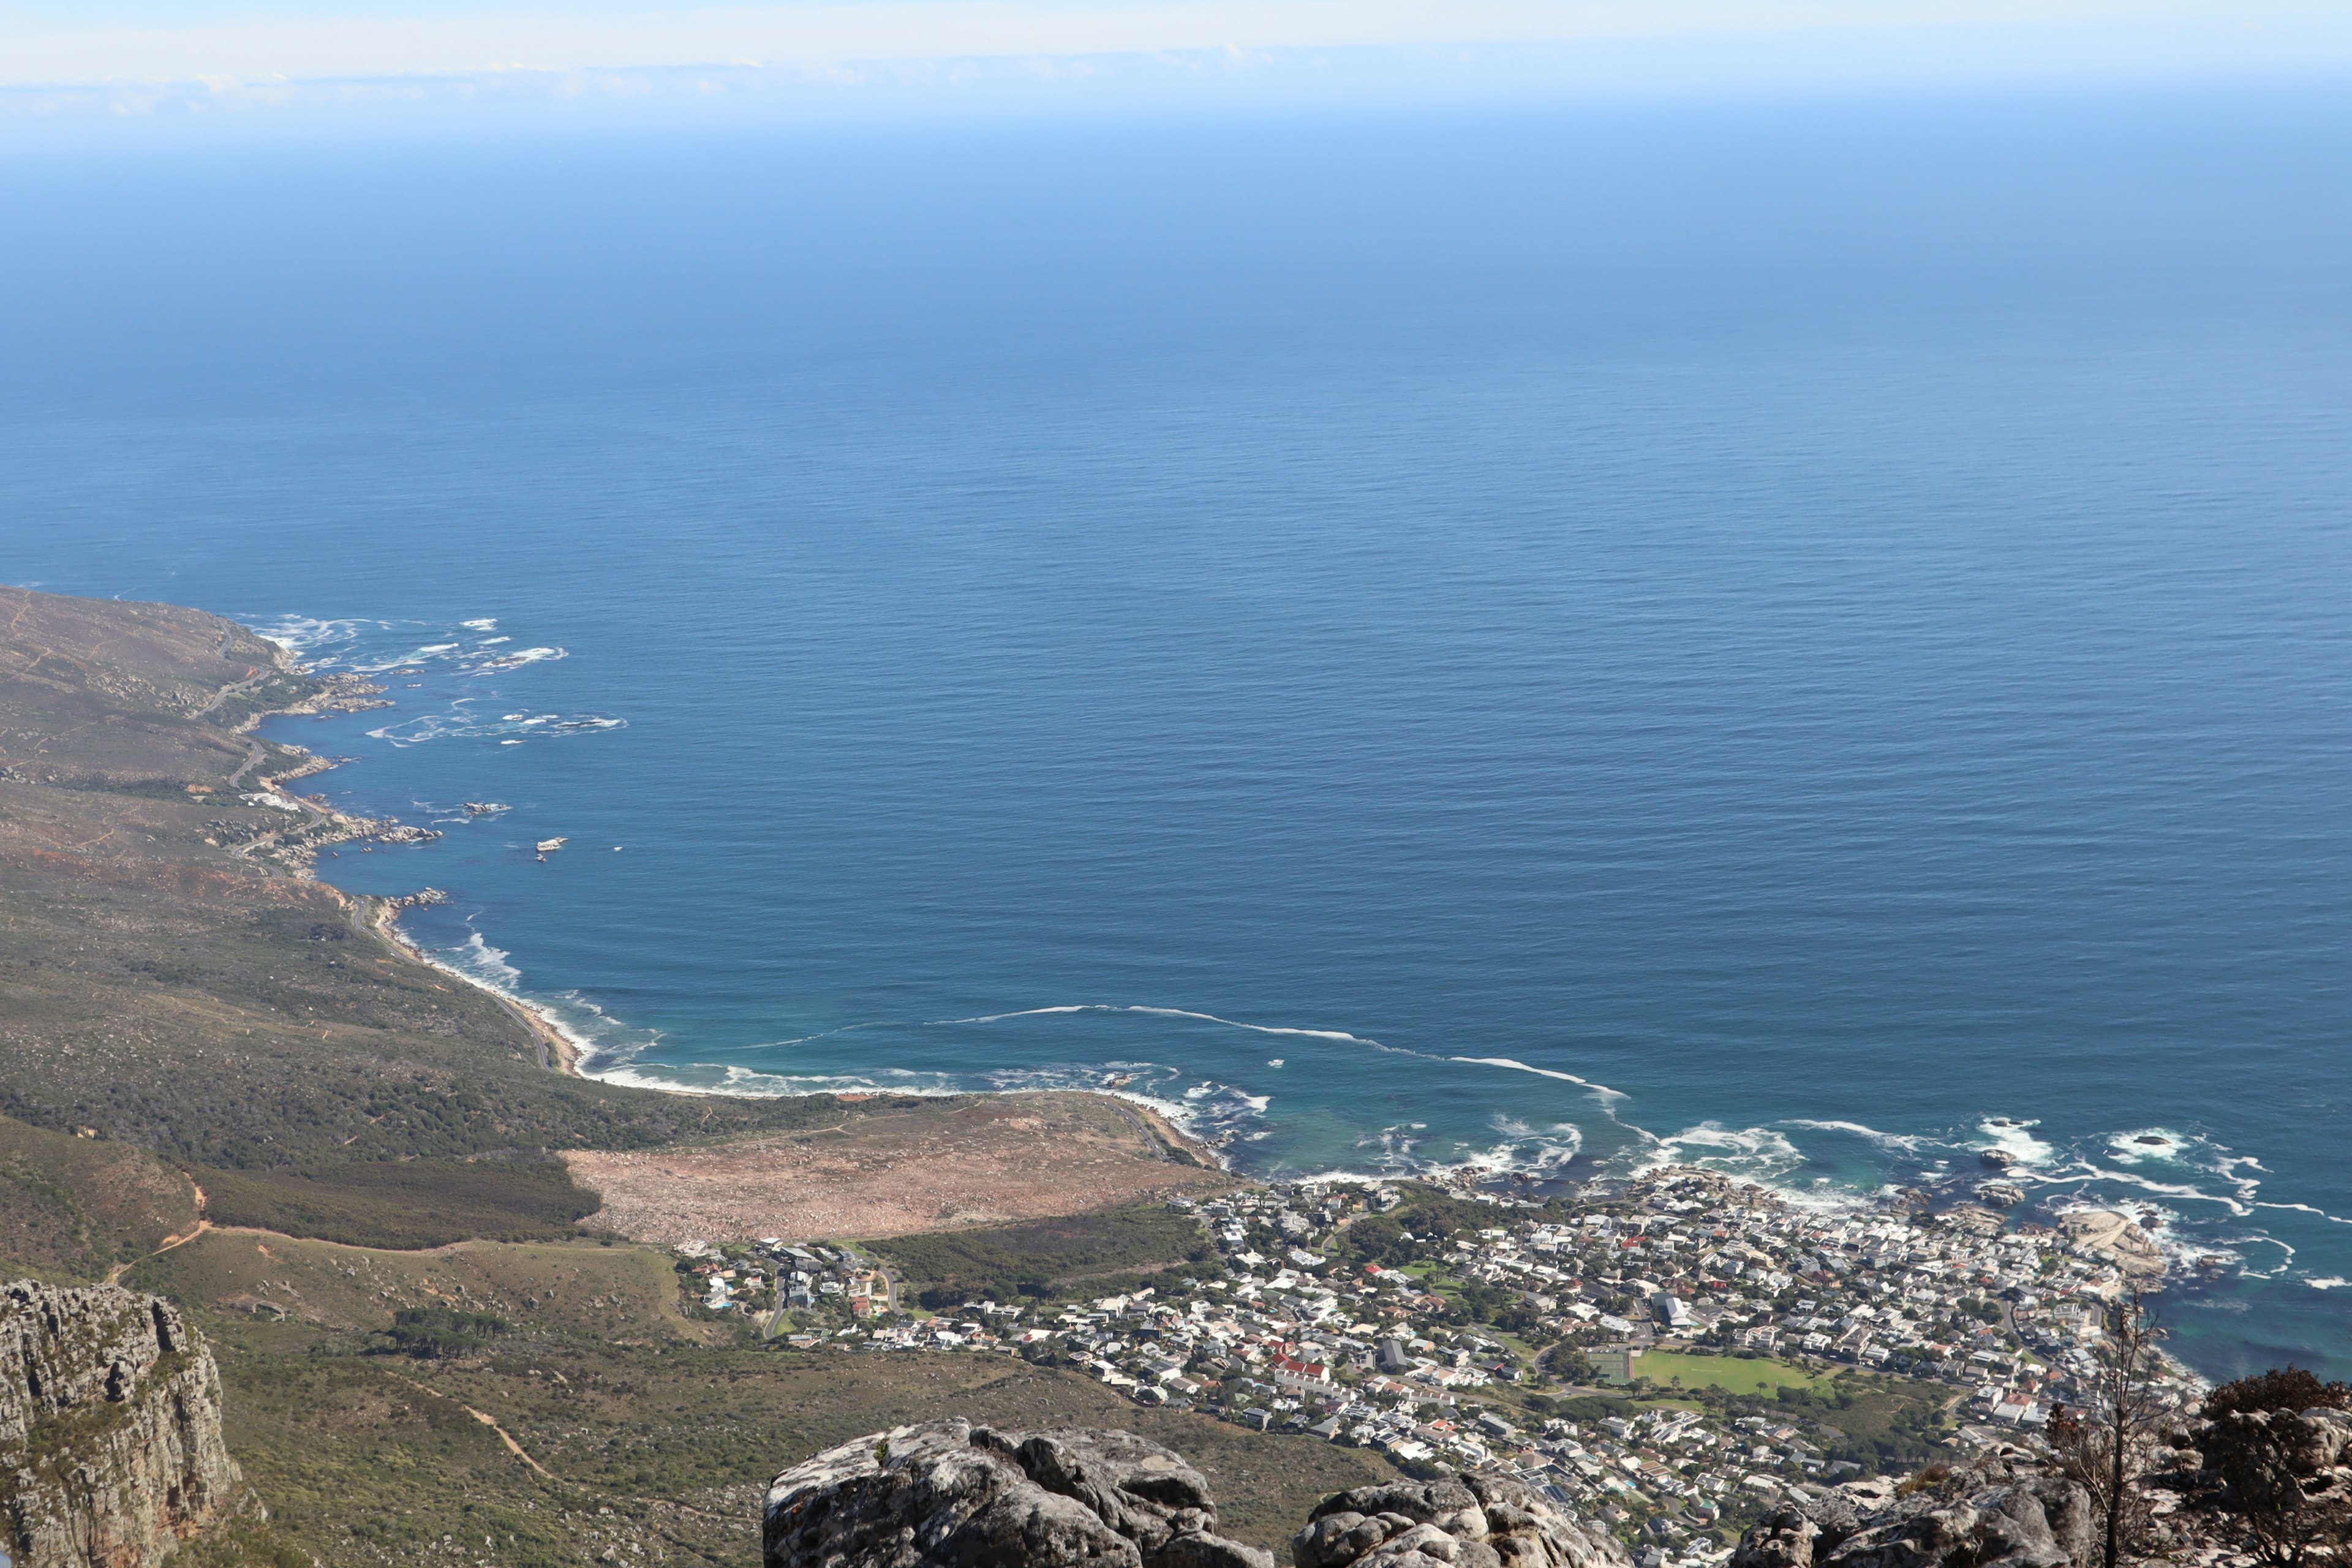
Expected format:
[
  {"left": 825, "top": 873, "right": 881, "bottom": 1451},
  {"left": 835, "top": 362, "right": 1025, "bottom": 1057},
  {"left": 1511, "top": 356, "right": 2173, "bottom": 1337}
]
[{"left": 1731, "top": 1469, "right": 2098, "bottom": 1568}]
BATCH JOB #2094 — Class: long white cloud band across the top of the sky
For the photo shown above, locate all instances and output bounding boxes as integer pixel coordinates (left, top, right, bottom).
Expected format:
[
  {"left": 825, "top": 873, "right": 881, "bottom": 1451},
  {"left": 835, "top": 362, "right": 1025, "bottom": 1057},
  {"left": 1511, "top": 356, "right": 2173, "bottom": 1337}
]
[{"left": 0, "top": 0, "right": 2352, "bottom": 123}]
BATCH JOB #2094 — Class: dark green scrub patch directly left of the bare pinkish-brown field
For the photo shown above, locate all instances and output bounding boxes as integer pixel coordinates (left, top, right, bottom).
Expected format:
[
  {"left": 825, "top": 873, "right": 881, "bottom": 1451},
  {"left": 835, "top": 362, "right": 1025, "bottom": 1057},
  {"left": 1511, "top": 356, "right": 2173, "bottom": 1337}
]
[{"left": 195, "top": 1159, "right": 597, "bottom": 1248}]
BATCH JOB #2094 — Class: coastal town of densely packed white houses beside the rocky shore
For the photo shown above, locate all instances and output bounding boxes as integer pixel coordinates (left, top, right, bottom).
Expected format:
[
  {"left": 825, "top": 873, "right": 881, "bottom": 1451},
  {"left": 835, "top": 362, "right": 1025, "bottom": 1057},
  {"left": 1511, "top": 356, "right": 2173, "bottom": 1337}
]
[{"left": 680, "top": 1169, "right": 2199, "bottom": 1561}]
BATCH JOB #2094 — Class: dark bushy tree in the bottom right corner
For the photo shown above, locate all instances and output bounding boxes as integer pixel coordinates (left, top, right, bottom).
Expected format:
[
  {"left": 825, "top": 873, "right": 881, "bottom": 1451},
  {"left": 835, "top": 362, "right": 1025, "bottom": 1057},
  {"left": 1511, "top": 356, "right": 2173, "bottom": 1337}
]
[{"left": 2199, "top": 1366, "right": 2352, "bottom": 1568}]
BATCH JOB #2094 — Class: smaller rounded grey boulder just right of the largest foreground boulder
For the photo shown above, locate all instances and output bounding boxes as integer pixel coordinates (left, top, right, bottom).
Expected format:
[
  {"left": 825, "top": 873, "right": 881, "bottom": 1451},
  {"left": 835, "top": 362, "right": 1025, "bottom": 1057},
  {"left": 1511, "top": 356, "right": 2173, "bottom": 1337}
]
[{"left": 1291, "top": 1472, "right": 1632, "bottom": 1568}]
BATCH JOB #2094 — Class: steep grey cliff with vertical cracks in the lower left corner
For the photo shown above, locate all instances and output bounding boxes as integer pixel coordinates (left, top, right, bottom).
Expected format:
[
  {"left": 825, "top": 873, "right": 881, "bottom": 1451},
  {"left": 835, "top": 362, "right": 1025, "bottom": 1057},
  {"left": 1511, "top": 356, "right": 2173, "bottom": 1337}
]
[{"left": 0, "top": 1279, "right": 240, "bottom": 1568}]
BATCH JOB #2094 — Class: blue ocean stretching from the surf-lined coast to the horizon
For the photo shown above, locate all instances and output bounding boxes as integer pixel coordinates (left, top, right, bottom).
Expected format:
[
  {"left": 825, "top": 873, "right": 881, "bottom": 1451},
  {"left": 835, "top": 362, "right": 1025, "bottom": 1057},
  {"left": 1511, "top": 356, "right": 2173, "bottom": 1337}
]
[{"left": 0, "top": 92, "right": 2352, "bottom": 1378}]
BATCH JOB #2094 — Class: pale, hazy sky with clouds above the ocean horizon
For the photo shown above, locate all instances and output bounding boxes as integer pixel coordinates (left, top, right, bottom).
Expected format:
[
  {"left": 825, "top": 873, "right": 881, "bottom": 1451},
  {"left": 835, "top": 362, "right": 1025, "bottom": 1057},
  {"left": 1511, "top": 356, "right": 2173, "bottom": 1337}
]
[{"left": 13, "top": 0, "right": 2352, "bottom": 138}]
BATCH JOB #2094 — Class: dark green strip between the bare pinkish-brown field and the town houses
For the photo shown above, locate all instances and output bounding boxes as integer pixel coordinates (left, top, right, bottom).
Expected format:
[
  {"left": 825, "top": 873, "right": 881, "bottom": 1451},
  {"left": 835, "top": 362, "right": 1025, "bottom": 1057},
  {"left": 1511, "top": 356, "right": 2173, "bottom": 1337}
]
[{"left": 870, "top": 1204, "right": 1216, "bottom": 1312}]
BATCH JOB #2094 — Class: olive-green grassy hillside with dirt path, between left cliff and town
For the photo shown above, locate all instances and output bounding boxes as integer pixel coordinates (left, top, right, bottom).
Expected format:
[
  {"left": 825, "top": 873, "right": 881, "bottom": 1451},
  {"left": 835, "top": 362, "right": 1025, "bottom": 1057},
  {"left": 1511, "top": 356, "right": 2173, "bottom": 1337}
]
[{"left": 127, "top": 1232, "right": 1392, "bottom": 1566}]
